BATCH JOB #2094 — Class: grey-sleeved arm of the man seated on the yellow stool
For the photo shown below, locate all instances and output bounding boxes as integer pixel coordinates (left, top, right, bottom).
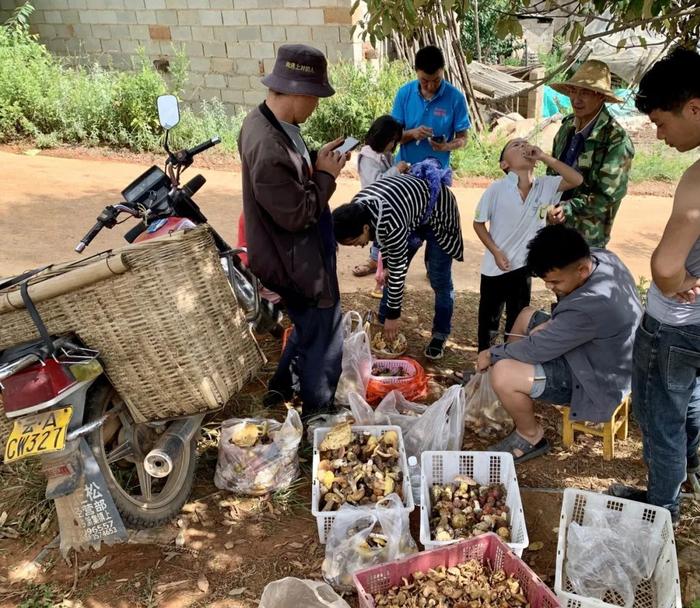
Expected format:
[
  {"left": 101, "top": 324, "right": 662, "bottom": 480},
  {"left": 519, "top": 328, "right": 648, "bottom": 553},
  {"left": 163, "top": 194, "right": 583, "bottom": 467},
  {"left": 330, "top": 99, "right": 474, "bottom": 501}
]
[{"left": 490, "top": 310, "right": 596, "bottom": 363}]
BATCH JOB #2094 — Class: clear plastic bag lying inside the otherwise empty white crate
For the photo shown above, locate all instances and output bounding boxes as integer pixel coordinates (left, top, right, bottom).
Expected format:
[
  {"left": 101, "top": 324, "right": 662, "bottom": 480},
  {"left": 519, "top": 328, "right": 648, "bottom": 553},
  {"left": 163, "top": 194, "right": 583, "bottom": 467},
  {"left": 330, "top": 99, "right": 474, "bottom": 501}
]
[{"left": 565, "top": 507, "right": 663, "bottom": 607}]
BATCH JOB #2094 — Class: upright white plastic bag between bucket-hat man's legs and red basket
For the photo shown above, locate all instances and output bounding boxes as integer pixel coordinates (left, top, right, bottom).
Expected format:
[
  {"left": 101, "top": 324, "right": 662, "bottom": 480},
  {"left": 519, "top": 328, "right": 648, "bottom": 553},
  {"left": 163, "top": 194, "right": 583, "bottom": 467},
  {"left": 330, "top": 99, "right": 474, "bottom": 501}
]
[{"left": 335, "top": 310, "right": 372, "bottom": 405}]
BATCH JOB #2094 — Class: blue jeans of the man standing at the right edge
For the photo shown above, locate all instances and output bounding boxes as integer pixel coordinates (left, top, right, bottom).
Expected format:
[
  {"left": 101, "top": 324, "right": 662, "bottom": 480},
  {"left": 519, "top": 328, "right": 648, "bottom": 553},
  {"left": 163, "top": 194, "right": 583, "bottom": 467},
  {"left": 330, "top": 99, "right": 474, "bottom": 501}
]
[{"left": 632, "top": 314, "right": 700, "bottom": 516}]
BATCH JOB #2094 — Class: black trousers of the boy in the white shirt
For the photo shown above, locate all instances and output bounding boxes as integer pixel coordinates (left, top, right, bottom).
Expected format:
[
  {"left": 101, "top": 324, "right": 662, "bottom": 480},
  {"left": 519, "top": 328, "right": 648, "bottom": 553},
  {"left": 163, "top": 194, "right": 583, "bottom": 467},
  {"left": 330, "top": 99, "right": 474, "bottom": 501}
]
[{"left": 478, "top": 266, "right": 532, "bottom": 352}]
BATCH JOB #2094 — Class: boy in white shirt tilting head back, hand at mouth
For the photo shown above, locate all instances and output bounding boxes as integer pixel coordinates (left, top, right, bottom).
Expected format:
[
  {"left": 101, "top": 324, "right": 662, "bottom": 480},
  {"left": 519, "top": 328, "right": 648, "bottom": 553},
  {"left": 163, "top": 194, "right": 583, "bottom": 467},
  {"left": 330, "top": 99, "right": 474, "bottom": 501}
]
[{"left": 474, "top": 139, "right": 583, "bottom": 352}]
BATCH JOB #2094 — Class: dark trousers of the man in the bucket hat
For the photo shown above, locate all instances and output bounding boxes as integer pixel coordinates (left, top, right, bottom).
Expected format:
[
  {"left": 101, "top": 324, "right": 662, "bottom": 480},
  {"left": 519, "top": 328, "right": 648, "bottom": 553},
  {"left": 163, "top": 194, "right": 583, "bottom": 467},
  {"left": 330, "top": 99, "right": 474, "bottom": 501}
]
[{"left": 269, "top": 302, "right": 343, "bottom": 418}]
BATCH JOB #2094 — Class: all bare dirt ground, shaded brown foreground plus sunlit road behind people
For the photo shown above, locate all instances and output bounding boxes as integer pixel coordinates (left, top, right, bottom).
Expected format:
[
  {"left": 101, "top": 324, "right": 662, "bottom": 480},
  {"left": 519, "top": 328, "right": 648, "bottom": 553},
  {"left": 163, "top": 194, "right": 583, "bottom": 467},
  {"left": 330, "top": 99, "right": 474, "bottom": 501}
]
[{"left": 0, "top": 151, "right": 700, "bottom": 608}]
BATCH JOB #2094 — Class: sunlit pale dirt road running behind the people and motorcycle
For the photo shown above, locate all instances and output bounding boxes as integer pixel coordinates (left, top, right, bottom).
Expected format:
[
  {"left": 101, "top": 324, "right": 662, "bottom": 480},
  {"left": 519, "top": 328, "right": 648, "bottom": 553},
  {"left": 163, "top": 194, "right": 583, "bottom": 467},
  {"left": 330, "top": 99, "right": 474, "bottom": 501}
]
[{"left": 0, "top": 152, "right": 671, "bottom": 291}]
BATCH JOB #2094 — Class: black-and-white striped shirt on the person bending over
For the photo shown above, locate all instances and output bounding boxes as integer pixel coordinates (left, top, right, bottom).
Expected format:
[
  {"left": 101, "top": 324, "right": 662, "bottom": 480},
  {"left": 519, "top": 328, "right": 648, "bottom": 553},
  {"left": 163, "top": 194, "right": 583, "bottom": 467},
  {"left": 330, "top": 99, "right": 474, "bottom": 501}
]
[{"left": 352, "top": 175, "right": 464, "bottom": 319}]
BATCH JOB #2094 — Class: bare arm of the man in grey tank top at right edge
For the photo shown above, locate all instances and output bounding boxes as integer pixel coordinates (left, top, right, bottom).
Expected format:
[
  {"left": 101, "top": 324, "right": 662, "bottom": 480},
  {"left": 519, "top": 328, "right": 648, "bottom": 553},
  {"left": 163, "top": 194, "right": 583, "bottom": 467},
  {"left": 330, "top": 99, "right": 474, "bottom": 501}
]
[{"left": 651, "top": 162, "right": 700, "bottom": 297}]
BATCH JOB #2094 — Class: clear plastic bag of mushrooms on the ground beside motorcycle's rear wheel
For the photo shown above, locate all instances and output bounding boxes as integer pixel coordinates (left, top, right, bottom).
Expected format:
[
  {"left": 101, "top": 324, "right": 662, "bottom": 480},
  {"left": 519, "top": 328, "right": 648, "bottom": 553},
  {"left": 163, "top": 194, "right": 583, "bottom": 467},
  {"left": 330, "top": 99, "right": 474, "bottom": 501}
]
[{"left": 214, "top": 409, "right": 303, "bottom": 496}]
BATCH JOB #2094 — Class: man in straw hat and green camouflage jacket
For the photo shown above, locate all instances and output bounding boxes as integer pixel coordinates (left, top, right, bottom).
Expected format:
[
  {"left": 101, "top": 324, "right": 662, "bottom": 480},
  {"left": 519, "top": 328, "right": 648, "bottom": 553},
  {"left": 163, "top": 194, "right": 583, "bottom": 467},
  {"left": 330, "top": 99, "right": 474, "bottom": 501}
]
[{"left": 551, "top": 60, "right": 634, "bottom": 247}]
